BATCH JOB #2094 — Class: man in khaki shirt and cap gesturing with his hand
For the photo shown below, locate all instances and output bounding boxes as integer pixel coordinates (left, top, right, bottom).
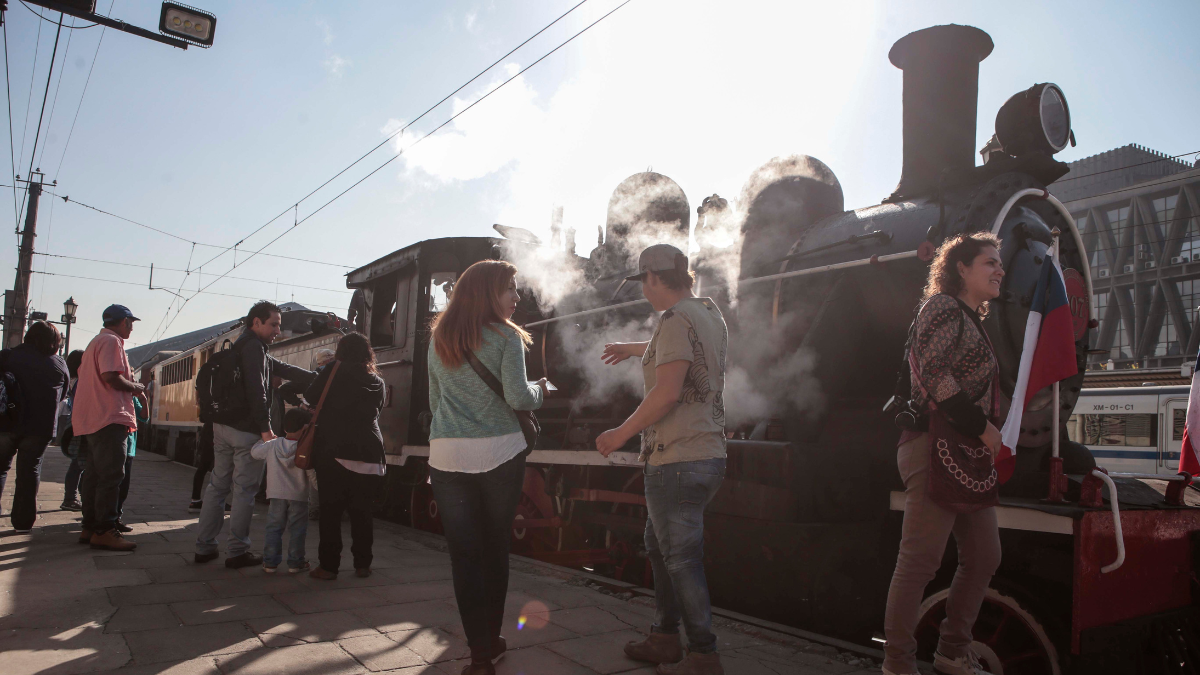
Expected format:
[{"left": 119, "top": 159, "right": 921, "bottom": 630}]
[{"left": 596, "top": 244, "right": 730, "bottom": 675}]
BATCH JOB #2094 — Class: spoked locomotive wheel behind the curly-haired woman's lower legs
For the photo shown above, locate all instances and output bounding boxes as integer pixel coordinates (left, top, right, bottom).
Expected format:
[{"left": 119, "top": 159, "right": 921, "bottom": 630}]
[{"left": 917, "top": 587, "right": 1062, "bottom": 675}]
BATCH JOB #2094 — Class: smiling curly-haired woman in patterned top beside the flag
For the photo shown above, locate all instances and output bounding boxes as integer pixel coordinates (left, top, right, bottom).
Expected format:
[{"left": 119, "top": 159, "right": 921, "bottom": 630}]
[{"left": 883, "top": 232, "right": 1004, "bottom": 675}]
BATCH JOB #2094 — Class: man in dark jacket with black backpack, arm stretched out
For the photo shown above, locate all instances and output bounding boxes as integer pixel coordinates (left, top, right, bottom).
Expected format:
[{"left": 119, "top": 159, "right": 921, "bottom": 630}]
[{"left": 196, "top": 300, "right": 317, "bottom": 568}]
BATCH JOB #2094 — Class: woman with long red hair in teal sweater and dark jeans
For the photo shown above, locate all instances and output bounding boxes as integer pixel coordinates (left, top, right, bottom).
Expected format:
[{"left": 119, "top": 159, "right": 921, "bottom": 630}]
[{"left": 429, "top": 261, "right": 546, "bottom": 675}]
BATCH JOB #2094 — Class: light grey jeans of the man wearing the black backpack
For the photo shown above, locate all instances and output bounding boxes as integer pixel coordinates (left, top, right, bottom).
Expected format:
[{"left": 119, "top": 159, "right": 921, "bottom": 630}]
[{"left": 196, "top": 424, "right": 263, "bottom": 557}]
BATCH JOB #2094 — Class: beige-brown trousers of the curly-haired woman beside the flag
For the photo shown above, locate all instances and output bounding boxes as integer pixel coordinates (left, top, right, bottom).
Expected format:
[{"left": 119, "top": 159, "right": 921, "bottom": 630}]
[{"left": 883, "top": 434, "right": 1000, "bottom": 675}]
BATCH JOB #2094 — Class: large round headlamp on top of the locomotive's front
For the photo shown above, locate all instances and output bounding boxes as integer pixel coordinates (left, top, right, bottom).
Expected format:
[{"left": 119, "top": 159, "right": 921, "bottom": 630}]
[{"left": 996, "top": 83, "right": 1075, "bottom": 156}]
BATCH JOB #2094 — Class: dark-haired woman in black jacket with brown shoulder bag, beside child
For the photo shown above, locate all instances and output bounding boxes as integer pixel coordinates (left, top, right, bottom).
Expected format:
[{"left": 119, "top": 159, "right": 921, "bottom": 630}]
[{"left": 304, "top": 333, "right": 386, "bottom": 580}]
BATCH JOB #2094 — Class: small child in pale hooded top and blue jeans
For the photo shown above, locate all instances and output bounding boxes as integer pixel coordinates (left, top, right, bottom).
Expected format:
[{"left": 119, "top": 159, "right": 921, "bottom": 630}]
[{"left": 250, "top": 408, "right": 312, "bottom": 574}]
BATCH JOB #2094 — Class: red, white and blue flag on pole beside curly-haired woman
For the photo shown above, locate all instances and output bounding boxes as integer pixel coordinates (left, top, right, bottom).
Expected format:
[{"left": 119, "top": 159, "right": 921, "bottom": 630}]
[{"left": 996, "top": 255, "right": 1080, "bottom": 483}]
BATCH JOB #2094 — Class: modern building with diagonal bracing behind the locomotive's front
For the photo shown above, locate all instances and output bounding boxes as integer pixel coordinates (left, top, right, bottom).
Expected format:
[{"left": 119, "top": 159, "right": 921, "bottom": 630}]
[{"left": 1050, "top": 145, "right": 1200, "bottom": 370}]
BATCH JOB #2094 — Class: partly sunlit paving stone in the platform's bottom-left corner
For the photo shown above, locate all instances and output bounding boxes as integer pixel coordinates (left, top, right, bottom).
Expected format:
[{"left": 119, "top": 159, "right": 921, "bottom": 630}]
[{"left": 0, "top": 623, "right": 130, "bottom": 675}]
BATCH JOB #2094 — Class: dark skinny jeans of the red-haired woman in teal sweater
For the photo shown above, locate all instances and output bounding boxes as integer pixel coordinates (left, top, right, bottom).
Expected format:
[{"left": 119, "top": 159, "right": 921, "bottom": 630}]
[{"left": 432, "top": 455, "right": 526, "bottom": 661}]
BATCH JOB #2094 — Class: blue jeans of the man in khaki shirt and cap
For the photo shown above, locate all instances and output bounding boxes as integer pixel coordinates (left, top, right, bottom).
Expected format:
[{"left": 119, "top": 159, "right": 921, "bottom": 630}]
[{"left": 648, "top": 459, "right": 725, "bottom": 653}]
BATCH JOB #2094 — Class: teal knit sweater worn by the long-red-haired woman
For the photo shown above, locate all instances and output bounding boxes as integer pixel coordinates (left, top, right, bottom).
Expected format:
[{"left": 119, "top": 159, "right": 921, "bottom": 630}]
[{"left": 430, "top": 324, "right": 542, "bottom": 441}]
